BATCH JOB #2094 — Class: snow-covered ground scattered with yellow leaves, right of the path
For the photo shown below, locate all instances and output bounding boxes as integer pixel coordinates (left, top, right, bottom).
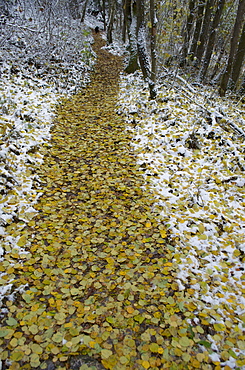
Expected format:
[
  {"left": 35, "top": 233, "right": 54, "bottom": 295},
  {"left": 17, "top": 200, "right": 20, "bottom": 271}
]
[{"left": 119, "top": 72, "right": 245, "bottom": 369}]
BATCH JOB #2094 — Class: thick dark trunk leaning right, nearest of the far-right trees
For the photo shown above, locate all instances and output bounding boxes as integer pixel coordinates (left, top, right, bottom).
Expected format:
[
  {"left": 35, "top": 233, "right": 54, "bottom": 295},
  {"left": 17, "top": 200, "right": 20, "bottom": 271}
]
[{"left": 219, "top": 0, "right": 245, "bottom": 96}]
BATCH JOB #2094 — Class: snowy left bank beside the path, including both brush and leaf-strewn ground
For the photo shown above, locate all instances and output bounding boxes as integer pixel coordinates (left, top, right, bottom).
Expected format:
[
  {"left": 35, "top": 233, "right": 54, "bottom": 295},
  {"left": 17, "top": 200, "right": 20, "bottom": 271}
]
[{"left": 0, "top": 1, "right": 94, "bottom": 307}]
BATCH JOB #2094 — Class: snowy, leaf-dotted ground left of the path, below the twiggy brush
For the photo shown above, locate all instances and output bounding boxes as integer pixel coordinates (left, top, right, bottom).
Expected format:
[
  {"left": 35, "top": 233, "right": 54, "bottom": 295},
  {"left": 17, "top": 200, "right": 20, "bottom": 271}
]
[{"left": 0, "top": 71, "right": 58, "bottom": 304}]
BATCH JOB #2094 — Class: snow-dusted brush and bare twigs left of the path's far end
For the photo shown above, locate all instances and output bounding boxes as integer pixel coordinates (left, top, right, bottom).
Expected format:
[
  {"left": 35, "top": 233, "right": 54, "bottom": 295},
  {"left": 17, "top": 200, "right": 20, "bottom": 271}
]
[{"left": 0, "top": 0, "right": 93, "bottom": 92}]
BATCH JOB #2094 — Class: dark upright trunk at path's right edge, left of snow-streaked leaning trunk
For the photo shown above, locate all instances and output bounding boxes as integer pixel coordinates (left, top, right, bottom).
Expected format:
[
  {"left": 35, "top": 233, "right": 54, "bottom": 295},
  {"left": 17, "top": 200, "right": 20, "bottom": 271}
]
[{"left": 125, "top": 0, "right": 139, "bottom": 73}]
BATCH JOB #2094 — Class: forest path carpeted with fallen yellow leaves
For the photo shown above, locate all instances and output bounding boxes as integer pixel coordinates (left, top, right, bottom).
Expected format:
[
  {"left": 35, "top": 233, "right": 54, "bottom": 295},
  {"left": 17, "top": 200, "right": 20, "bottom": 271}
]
[{"left": 0, "top": 35, "right": 244, "bottom": 370}]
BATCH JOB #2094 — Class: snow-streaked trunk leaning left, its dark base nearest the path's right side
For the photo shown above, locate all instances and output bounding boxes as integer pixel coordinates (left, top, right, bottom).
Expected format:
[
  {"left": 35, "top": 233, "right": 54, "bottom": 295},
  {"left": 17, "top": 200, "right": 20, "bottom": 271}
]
[{"left": 136, "top": 0, "right": 156, "bottom": 99}]
